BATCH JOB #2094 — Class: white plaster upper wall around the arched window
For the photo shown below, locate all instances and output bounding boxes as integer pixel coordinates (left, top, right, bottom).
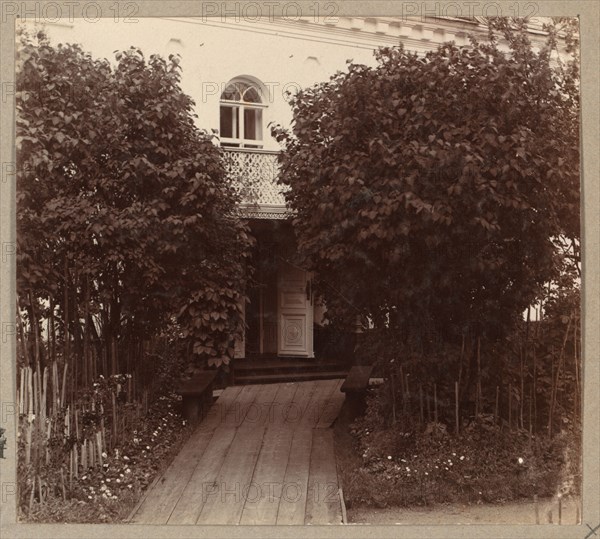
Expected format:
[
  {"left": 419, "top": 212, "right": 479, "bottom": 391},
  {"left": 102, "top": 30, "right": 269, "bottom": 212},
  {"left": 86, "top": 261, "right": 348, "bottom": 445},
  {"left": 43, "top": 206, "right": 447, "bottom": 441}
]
[{"left": 32, "top": 19, "right": 454, "bottom": 149}]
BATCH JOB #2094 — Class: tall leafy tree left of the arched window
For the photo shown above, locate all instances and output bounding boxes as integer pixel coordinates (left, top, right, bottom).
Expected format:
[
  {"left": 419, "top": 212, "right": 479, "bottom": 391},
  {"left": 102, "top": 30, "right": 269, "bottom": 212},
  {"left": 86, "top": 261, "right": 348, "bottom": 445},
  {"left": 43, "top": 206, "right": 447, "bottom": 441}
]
[{"left": 16, "top": 29, "right": 250, "bottom": 382}]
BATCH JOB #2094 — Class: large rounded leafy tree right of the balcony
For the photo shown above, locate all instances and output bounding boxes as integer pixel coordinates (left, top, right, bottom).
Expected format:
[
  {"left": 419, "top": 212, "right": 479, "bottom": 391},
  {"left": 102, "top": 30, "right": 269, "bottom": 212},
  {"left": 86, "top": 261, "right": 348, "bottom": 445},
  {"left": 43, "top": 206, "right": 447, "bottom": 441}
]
[{"left": 274, "top": 19, "right": 579, "bottom": 350}]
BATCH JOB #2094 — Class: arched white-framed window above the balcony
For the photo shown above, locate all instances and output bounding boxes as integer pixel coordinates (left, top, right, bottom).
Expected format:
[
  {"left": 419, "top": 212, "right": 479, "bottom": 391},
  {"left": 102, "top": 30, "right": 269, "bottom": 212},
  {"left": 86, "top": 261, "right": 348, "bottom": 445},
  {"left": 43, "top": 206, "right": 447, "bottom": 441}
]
[{"left": 220, "top": 80, "right": 267, "bottom": 148}]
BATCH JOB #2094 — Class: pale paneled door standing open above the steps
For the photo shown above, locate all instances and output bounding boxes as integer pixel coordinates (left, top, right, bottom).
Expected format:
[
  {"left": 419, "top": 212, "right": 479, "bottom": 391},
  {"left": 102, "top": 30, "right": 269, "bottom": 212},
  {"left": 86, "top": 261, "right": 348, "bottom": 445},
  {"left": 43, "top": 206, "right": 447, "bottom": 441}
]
[{"left": 277, "top": 261, "right": 314, "bottom": 358}]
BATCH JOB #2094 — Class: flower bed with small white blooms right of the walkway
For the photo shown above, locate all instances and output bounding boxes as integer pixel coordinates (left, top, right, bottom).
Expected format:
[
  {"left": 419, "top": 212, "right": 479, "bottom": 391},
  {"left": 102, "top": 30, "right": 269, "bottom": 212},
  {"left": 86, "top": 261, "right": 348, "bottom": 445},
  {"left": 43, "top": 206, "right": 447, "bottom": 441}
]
[{"left": 335, "top": 390, "right": 580, "bottom": 518}]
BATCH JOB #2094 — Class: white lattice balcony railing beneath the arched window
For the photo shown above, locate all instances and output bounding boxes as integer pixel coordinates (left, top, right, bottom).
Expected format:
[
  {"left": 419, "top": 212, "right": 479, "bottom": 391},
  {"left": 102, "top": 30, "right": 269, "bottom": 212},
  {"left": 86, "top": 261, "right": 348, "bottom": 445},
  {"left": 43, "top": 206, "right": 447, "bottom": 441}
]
[{"left": 223, "top": 148, "right": 289, "bottom": 219}]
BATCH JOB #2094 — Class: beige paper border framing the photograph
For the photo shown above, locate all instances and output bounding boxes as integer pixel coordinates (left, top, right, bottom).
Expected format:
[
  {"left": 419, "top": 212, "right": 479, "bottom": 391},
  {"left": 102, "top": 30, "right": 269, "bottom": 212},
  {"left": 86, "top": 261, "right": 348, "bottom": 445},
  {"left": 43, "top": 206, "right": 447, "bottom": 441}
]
[{"left": 0, "top": 0, "right": 600, "bottom": 539}]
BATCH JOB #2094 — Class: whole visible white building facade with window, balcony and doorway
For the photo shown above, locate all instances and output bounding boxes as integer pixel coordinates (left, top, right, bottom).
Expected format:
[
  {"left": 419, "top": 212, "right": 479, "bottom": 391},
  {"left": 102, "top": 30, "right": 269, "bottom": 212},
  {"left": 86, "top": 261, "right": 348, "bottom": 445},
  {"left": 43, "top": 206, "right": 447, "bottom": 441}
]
[{"left": 38, "top": 17, "right": 556, "bottom": 358}]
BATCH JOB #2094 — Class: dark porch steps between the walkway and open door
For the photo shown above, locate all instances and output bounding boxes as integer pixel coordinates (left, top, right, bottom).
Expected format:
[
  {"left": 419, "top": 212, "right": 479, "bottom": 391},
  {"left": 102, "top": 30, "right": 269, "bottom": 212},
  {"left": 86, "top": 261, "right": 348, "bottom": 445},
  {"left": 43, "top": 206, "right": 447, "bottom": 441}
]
[{"left": 233, "top": 359, "right": 349, "bottom": 385}]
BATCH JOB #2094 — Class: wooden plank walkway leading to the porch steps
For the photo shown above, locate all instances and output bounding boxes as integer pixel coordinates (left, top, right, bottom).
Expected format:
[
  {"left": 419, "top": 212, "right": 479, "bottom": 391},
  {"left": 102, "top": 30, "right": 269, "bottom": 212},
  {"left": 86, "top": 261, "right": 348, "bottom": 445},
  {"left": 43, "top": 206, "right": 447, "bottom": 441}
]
[{"left": 131, "top": 379, "right": 344, "bottom": 525}]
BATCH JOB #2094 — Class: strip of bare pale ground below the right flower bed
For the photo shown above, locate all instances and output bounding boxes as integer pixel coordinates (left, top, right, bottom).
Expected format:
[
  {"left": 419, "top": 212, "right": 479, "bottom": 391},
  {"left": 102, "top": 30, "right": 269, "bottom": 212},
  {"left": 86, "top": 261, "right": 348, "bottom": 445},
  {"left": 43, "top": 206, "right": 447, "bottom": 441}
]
[{"left": 348, "top": 498, "right": 581, "bottom": 526}]
